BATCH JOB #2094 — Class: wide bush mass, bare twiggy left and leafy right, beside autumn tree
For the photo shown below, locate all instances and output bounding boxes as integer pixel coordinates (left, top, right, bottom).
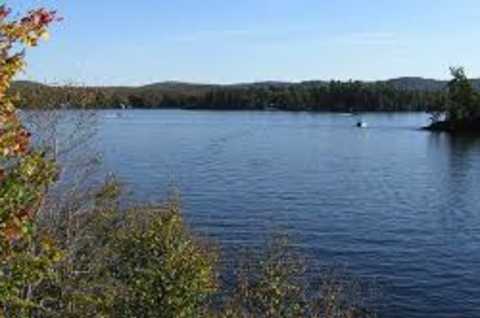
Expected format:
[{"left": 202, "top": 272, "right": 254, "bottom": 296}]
[{"left": 31, "top": 180, "right": 217, "bottom": 318}]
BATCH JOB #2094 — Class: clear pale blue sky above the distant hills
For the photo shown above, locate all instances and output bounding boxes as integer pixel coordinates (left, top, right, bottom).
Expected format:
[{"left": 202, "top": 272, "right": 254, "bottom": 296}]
[{"left": 11, "top": 0, "right": 480, "bottom": 85}]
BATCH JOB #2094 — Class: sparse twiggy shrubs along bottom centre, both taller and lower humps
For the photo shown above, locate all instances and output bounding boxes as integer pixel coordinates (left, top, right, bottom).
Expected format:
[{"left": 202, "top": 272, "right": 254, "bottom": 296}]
[{"left": 218, "top": 237, "right": 375, "bottom": 318}]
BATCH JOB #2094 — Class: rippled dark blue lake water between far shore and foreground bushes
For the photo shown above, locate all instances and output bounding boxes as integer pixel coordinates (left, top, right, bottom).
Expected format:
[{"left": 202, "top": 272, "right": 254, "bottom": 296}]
[{"left": 100, "top": 110, "right": 480, "bottom": 317}]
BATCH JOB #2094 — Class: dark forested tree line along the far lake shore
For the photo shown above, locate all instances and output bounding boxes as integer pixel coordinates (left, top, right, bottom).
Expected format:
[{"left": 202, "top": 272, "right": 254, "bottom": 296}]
[{"left": 13, "top": 78, "right": 447, "bottom": 112}]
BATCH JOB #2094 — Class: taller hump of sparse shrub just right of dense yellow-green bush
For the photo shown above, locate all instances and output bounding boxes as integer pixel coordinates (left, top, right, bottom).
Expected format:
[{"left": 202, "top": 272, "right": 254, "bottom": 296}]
[{"left": 221, "top": 238, "right": 310, "bottom": 318}]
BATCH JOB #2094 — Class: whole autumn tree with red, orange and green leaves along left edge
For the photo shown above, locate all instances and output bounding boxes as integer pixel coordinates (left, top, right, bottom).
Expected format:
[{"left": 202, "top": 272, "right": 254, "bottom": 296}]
[{"left": 0, "top": 6, "right": 60, "bottom": 317}]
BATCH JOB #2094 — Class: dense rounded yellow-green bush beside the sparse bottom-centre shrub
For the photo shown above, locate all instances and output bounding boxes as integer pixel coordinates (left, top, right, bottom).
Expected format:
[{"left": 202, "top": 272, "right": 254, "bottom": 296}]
[{"left": 109, "top": 204, "right": 216, "bottom": 317}]
